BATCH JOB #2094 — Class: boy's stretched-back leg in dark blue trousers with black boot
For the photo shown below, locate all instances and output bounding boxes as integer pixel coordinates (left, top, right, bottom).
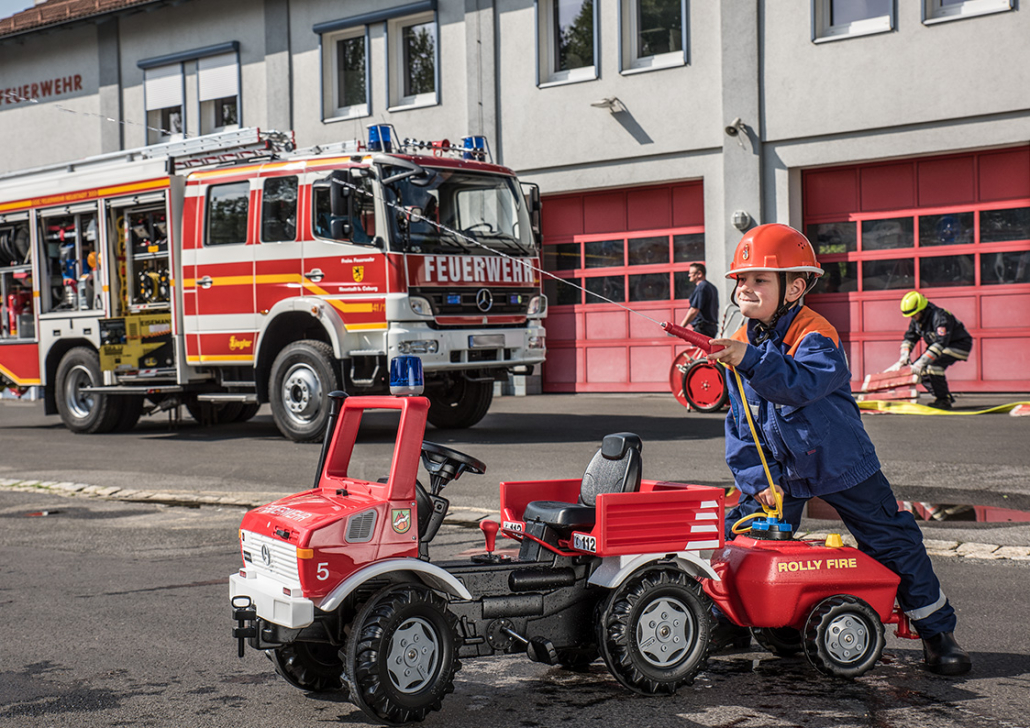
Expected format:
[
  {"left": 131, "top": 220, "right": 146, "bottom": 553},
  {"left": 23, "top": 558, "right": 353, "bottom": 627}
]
[{"left": 820, "top": 471, "right": 955, "bottom": 636}]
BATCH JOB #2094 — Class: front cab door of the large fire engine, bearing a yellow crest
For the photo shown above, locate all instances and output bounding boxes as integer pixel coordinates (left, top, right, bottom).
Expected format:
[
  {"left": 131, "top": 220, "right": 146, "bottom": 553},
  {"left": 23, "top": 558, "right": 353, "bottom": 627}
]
[{"left": 302, "top": 174, "right": 386, "bottom": 331}]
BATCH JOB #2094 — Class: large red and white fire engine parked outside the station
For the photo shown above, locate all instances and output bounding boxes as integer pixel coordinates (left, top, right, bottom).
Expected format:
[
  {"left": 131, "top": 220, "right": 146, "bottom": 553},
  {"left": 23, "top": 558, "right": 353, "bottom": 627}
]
[{"left": 0, "top": 126, "right": 547, "bottom": 441}]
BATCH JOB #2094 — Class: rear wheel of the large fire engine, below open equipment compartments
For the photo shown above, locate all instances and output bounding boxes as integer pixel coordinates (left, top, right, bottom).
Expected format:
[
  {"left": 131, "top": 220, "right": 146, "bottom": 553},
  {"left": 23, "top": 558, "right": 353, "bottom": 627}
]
[{"left": 55, "top": 346, "right": 122, "bottom": 435}]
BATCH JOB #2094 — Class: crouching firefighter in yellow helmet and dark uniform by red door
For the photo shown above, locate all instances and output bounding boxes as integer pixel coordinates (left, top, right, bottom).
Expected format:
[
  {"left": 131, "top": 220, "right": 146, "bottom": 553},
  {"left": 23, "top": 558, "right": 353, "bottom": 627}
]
[{"left": 887, "top": 290, "right": 972, "bottom": 410}]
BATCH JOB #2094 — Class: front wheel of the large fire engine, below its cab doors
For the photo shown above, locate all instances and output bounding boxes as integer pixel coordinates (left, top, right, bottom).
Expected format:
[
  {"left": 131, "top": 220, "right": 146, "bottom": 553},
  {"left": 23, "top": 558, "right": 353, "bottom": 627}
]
[{"left": 268, "top": 339, "right": 343, "bottom": 443}]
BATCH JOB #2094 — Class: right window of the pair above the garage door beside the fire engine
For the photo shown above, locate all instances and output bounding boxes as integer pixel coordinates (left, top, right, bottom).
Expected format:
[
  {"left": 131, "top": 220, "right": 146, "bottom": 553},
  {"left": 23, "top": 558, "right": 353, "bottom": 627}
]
[{"left": 622, "top": 0, "right": 686, "bottom": 73}]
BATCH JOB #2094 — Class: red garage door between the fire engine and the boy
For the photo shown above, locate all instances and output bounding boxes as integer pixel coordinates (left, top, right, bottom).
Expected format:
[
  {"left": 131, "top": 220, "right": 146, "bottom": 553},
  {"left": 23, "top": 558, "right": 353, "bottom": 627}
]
[{"left": 543, "top": 182, "right": 705, "bottom": 392}]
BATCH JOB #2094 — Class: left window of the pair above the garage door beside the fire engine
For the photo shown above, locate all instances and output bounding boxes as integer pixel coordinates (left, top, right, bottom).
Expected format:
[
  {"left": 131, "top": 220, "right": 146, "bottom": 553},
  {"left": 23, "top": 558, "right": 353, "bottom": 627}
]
[{"left": 537, "top": 0, "right": 597, "bottom": 85}]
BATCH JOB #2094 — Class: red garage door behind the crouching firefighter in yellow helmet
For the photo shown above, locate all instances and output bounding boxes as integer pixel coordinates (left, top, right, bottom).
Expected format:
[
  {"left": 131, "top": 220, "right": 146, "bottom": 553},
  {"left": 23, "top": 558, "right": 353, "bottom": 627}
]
[{"left": 802, "top": 146, "right": 1030, "bottom": 391}]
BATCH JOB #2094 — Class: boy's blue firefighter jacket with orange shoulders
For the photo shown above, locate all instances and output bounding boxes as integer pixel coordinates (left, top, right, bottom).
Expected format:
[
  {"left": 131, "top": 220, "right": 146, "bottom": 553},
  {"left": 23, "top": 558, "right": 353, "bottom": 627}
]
[{"left": 726, "top": 306, "right": 880, "bottom": 498}]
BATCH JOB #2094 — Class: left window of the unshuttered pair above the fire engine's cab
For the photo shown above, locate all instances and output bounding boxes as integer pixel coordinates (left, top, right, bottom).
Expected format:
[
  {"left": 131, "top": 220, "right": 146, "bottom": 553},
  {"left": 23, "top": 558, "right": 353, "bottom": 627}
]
[{"left": 322, "top": 26, "right": 369, "bottom": 118}]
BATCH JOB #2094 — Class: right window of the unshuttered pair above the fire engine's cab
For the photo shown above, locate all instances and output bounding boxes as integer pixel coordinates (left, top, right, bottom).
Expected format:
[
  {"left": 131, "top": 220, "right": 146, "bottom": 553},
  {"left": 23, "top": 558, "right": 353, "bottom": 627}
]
[{"left": 386, "top": 12, "right": 439, "bottom": 109}]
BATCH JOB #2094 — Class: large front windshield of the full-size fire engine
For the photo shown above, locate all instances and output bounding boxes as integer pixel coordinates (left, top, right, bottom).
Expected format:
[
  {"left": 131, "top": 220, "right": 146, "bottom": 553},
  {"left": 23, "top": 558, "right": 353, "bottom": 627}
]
[{"left": 386, "top": 169, "right": 535, "bottom": 255}]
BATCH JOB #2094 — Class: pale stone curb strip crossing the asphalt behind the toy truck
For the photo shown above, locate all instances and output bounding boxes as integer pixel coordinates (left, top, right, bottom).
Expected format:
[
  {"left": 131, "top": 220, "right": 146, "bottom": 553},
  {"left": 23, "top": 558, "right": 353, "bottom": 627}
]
[{"left": 0, "top": 478, "right": 1030, "bottom": 561}]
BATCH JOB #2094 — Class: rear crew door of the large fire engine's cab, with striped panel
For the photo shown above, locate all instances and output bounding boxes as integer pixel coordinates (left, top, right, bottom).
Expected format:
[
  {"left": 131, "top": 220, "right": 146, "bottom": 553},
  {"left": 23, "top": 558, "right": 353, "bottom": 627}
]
[{"left": 186, "top": 180, "right": 259, "bottom": 365}]
